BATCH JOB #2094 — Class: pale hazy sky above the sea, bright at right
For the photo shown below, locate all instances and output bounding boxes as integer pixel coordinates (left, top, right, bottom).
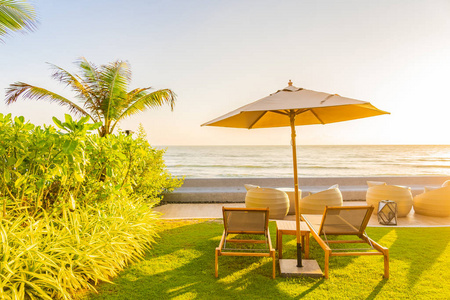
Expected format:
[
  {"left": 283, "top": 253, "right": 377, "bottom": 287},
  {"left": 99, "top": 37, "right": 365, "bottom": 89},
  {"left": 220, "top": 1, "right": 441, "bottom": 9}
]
[{"left": 0, "top": 0, "right": 450, "bottom": 146}]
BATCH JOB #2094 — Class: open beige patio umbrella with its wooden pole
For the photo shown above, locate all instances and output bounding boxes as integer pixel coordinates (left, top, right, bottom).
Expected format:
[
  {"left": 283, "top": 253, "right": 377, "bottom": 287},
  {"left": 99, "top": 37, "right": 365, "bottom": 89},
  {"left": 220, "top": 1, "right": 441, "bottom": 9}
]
[{"left": 202, "top": 80, "right": 388, "bottom": 267}]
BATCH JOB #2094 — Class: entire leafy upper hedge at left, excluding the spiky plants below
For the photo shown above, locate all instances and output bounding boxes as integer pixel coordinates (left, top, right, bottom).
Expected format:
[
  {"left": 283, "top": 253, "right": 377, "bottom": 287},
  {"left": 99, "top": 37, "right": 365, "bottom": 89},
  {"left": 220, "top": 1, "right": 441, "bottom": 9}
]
[{"left": 0, "top": 114, "right": 181, "bottom": 215}]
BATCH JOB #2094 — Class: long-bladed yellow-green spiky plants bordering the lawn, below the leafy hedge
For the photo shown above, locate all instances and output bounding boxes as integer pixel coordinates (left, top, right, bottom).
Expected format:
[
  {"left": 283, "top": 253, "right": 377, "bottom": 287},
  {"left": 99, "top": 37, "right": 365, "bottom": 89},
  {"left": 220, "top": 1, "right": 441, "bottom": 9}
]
[{"left": 0, "top": 197, "right": 157, "bottom": 299}]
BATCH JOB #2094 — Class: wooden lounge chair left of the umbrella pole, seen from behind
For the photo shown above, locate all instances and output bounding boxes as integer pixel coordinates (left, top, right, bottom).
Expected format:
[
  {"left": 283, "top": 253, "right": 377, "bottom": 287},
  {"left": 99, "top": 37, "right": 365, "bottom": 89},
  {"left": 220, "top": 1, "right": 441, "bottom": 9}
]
[{"left": 215, "top": 207, "right": 275, "bottom": 278}]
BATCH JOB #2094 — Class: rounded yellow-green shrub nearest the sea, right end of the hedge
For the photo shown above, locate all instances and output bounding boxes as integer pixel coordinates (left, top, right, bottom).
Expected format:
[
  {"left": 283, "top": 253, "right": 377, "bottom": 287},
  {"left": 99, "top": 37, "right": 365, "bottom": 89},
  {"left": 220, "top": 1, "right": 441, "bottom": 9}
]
[{"left": 83, "top": 123, "right": 182, "bottom": 203}]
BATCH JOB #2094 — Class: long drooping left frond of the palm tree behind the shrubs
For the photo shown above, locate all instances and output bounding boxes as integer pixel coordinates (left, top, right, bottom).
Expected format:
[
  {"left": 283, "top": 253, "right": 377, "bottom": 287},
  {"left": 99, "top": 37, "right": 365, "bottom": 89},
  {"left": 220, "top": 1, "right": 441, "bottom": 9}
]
[{"left": 5, "top": 82, "right": 95, "bottom": 121}]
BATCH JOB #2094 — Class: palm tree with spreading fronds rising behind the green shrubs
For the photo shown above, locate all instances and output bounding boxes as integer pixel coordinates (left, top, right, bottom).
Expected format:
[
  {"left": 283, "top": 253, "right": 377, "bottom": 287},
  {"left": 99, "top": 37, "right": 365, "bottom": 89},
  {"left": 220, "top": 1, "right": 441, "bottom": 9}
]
[{"left": 5, "top": 58, "right": 176, "bottom": 136}]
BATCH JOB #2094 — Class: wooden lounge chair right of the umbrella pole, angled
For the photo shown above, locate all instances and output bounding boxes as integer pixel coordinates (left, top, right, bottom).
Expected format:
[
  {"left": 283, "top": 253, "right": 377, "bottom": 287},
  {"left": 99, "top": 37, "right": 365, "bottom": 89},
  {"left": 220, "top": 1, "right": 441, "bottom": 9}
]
[{"left": 302, "top": 206, "right": 389, "bottom": 278}]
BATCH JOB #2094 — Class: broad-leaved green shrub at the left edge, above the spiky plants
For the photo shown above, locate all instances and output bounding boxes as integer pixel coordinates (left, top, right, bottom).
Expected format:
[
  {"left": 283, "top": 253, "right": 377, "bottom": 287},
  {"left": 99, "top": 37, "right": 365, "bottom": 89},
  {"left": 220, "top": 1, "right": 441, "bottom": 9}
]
[{"left": 0, "top": 114, "right": 95, "bottom": 214}]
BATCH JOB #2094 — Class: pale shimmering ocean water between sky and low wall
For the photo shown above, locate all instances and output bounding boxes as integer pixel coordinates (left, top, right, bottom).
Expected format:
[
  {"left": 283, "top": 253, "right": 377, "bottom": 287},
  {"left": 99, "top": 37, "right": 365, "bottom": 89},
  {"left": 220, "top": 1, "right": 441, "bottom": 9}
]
[{"left": 157, "top": 145, "right": 450, "bottom": 178}]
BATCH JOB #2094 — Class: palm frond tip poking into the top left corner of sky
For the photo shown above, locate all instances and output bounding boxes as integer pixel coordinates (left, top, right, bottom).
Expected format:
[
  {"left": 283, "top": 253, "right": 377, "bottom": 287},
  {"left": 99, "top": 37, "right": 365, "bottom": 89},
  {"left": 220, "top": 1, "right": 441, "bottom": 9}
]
[{"left": 0, "top": 0, "right": 36, "bottom": 41}]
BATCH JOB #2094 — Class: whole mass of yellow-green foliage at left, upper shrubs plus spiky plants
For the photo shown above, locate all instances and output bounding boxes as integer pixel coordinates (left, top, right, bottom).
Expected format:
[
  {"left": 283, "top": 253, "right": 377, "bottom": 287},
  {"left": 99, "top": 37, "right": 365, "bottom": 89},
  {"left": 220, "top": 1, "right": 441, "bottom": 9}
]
[{"left": 0, "top": 114, "right": 181, "bottom": 299}]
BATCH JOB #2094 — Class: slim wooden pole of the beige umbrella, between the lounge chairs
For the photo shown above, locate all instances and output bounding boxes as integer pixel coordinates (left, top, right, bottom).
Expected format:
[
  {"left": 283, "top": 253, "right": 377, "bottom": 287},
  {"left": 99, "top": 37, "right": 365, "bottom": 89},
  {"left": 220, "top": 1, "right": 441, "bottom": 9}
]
[{"left": 289, "top": 110, "right": 303, "bottom": 267}]
